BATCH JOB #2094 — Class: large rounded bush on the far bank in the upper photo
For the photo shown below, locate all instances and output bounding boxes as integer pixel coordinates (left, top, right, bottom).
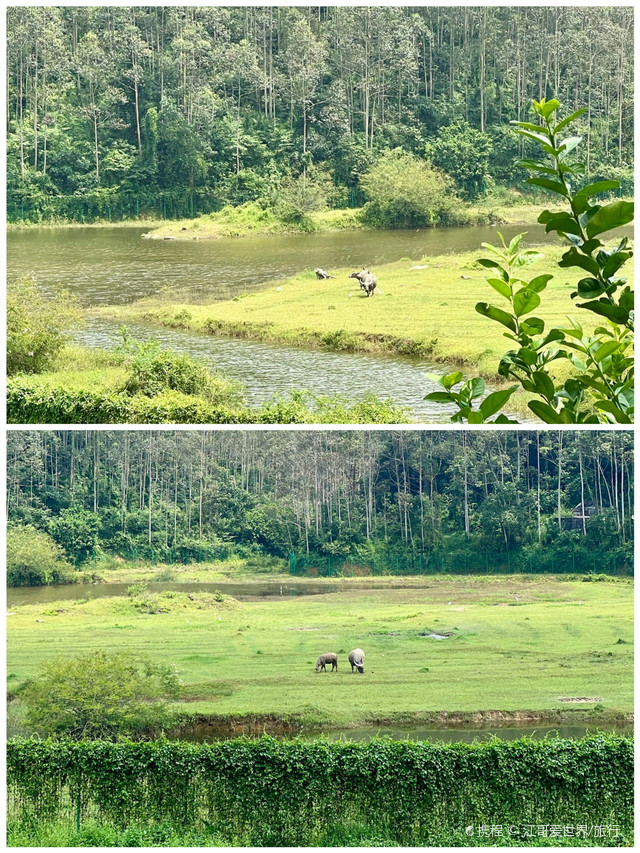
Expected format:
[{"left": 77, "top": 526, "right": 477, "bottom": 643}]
[{"left": 360, "top": 149, "right": 465, "bottom": 228}]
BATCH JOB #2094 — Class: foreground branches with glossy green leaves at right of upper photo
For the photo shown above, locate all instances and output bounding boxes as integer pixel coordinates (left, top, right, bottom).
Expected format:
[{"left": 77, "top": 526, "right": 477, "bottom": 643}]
[{"left": 426, "top": 99, "right": 634, "bottom": 424}]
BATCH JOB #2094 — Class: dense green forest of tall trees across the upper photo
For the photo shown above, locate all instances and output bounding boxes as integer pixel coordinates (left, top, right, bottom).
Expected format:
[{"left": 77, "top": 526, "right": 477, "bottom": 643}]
[{"left": 6, "top": 6, "right": 633, "bottom": 221}]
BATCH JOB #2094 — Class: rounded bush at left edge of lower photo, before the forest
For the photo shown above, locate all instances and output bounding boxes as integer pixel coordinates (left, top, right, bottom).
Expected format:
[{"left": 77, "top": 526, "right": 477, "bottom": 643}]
[{"left": 7, "top": 525, "right": 75, "bottom": 586}]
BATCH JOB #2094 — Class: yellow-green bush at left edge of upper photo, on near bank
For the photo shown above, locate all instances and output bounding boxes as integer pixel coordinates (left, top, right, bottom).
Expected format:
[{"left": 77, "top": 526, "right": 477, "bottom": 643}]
[{"left": 7, "top": 277, "right": 80, "bottom": 376}]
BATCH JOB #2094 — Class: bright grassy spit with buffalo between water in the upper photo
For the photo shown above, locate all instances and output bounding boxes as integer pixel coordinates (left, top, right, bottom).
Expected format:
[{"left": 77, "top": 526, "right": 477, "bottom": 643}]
[{"left": 95, "top": 240, "right": 633, "bottom": 378}]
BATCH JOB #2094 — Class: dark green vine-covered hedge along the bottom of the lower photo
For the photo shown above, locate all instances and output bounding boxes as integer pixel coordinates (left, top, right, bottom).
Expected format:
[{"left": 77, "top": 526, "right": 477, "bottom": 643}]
[{"left": 7, "top": 734, "right": 633, "bottom": 846}]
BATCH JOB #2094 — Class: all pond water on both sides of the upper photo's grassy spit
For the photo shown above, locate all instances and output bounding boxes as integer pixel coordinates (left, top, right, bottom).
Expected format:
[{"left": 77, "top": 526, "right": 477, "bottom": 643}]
[{"left": 7, "top": 225, "right": 564, "bottom": 422}]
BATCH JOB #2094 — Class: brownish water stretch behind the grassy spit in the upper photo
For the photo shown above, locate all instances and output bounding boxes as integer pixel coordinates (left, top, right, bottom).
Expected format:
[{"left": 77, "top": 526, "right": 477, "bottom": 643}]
[{"left": 7, "top": 224, "right": 550, "bottom": 306}]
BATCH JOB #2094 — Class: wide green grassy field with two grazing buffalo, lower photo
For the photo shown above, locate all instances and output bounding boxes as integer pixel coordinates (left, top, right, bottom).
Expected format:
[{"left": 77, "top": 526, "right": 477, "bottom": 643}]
[{"left": 7, "top": 576, "right": 633, "bottom": 728}]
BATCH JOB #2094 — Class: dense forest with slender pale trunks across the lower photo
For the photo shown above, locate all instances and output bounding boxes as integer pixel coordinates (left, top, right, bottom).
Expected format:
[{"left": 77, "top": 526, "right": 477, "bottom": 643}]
[{"left": 7, "top": 430, "right": 633, "bottom": 570}]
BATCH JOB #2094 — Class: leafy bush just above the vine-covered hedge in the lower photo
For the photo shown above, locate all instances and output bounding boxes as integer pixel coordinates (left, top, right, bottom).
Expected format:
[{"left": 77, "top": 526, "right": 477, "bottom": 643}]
[{"left": 20, "top": 651, "right": 179, "bottom": 740}]
